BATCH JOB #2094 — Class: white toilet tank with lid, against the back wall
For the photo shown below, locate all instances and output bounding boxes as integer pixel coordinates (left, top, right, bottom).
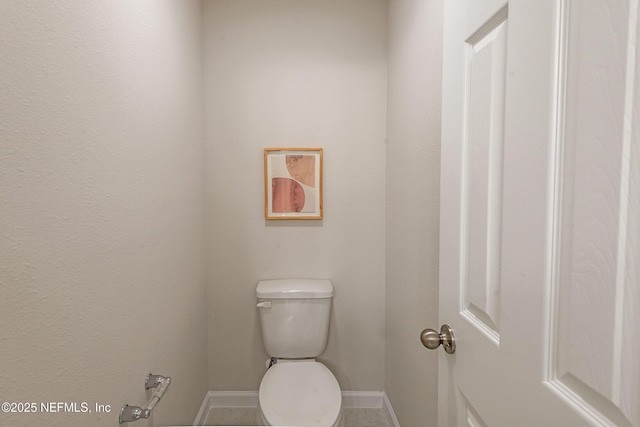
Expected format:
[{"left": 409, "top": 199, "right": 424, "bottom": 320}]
[{"left": 256, "top": 279, "right": 333, "bottom": 359}]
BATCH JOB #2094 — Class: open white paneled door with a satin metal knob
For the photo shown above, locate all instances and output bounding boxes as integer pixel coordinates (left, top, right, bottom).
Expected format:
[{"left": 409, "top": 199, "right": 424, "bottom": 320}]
[{"left": 432, "top": 0, "right": 640, "bottom": 427}]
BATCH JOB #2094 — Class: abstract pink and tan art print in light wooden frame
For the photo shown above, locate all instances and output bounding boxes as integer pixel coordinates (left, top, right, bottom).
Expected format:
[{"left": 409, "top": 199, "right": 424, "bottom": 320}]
[{"left": 264, "top": 148, "right": 322, "bottom": 219}]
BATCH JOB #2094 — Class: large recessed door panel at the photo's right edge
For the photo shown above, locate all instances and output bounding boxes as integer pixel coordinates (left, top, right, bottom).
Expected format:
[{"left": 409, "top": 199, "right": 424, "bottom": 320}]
[{"left": 548, "top": 1, "right": 640, "bottom": 426}]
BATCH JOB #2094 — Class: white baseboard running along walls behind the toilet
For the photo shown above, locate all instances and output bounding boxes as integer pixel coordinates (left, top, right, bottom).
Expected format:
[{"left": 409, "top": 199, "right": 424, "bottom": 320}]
[{"left": 193, "top": 391, "right": 400, "bottom": 427}]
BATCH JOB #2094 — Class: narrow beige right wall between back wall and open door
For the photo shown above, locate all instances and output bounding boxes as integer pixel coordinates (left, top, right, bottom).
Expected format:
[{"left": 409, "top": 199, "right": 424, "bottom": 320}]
[{"left": 385, "top": 0, "right": 442, "bottom": 426}]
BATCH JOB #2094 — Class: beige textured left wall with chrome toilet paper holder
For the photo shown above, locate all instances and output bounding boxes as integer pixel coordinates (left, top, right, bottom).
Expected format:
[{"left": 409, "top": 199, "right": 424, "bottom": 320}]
[{"left": 0, "top": 0, "right": 207, "bottom": 426}]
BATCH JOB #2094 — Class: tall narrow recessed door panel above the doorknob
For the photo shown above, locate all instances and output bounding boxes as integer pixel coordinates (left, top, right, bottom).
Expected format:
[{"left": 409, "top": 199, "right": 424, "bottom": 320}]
[{"left": 461, "top": 7, "right": 507, "bottom": 344}]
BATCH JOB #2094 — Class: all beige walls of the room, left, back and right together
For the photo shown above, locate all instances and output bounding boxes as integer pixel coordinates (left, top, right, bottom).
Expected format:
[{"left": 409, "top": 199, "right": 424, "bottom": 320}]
[{"left": 0, "top": 0, "right": 442, "bottom": 426}]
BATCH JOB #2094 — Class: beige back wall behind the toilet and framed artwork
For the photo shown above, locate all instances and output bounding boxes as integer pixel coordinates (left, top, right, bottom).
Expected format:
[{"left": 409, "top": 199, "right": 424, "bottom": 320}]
[{"left": 205, "top": 0, "right": 387, "bottom": 390}]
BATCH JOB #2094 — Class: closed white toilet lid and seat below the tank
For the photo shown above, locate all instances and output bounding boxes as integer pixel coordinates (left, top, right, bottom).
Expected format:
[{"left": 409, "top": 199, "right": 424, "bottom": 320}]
[{"left": 258, "top": 360, "right": 342, "bottom": 427}]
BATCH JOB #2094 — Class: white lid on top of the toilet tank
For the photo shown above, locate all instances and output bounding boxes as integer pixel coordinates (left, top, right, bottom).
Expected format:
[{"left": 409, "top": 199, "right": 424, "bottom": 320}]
[{"left": 256, "top": 279, "right": 333, "bottom": 299}]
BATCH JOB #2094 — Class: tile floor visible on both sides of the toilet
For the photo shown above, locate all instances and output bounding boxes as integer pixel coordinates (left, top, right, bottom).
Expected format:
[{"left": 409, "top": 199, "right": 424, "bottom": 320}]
[{"left": 206, "top": 408, "right": 391, "bottom": 427}]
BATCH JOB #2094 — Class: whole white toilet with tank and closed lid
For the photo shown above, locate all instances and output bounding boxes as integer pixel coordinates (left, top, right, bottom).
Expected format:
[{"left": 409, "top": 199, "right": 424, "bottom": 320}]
[{"left": 256, "top": 279, "right": 343, "bottom": 427}]
